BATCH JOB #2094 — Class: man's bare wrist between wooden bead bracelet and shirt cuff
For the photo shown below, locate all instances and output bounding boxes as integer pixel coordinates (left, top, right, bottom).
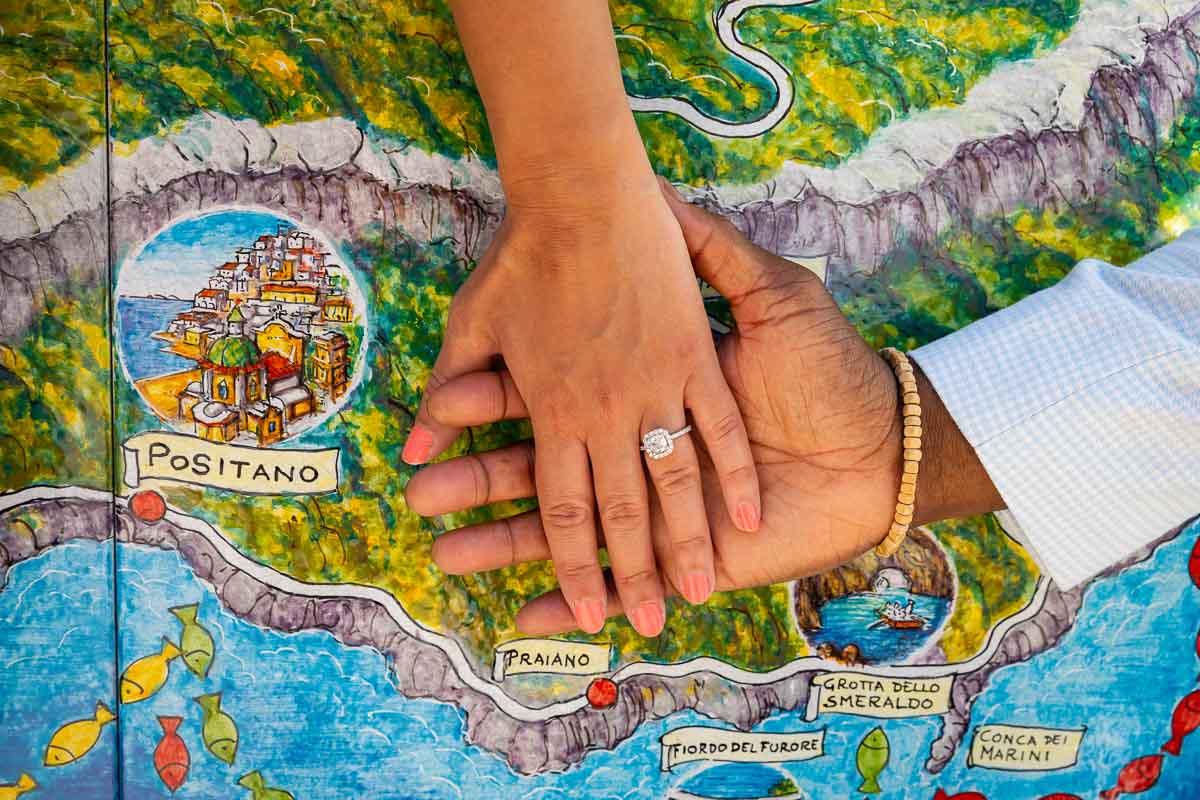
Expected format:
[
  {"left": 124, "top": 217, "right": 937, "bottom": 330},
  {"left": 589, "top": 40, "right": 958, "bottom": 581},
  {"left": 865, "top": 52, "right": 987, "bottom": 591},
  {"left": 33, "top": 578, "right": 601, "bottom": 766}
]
[{"left": 912, "top": 361, "right": 1004, "bottom": 525}]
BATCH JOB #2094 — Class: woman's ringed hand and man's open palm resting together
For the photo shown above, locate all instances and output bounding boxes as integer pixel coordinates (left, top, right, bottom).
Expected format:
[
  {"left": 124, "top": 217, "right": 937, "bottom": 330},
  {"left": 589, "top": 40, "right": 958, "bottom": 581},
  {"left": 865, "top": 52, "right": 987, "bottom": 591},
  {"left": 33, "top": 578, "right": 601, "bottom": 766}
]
[{"left": 403, "top": 180, "right": 931, "bottom": 637}]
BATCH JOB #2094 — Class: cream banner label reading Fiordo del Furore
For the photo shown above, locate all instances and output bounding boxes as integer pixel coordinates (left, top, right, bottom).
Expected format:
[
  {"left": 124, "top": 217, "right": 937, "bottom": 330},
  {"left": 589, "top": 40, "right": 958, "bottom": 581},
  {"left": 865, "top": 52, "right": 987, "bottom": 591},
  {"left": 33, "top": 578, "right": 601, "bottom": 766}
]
[{"left": 659, "top": 726, "right": 824, "bottom": 772}]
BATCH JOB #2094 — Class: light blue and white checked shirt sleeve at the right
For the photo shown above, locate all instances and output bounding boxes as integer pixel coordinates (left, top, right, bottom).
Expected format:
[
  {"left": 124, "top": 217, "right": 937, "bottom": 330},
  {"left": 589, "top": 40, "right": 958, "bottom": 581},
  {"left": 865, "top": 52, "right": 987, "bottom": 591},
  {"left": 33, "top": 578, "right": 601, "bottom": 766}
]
[{"left": 911, "top": 229, "right": 1200, "bottom": 589}]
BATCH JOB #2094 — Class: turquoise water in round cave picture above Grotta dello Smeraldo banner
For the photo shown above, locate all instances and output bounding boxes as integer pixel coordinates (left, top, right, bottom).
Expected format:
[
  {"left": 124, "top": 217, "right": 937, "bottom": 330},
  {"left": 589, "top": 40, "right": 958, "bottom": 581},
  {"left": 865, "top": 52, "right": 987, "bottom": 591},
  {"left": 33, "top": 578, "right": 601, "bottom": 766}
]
[{"left": 804, "top": 589, "right": 950, "bottom": 664}]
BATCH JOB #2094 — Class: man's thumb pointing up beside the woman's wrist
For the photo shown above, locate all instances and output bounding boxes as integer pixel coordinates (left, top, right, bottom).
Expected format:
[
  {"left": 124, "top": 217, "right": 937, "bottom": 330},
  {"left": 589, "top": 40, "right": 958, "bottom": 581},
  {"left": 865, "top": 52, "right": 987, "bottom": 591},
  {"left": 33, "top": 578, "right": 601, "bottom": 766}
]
[{"left": 659, "top": 178, "right": 808, "bottom": 324}]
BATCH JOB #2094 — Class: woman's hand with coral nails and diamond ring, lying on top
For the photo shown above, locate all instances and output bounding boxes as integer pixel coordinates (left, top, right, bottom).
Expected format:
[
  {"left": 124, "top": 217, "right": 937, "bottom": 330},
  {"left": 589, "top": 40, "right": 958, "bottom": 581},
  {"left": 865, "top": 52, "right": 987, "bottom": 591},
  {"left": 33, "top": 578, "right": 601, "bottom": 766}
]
[{"left": 403, "top": 175, "right": 761, "bottom": 636}]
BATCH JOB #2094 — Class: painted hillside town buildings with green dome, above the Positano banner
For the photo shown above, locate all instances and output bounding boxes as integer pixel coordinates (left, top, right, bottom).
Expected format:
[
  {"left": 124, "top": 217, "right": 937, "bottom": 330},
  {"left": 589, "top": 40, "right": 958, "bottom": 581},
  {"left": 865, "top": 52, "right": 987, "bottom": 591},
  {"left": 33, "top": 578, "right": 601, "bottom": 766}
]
[{"left": 129, "top": 225, "right": 354, "bottom": 447}]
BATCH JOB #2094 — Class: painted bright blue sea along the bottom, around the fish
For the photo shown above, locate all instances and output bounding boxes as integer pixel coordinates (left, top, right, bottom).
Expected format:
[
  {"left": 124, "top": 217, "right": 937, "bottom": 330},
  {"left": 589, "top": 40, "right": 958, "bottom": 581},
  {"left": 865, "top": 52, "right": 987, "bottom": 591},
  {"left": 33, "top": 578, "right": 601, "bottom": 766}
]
[{"left": 0, "top": 525, "right": 1200, "bottom": 800}]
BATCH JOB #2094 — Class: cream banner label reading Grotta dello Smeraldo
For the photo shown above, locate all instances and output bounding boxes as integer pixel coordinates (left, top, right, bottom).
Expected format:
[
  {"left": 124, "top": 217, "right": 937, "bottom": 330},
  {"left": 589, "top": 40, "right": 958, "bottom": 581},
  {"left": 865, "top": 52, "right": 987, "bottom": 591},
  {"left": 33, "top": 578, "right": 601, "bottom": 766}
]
[{"left": 804, "top": 673, "right": 954, "bottom": 722}]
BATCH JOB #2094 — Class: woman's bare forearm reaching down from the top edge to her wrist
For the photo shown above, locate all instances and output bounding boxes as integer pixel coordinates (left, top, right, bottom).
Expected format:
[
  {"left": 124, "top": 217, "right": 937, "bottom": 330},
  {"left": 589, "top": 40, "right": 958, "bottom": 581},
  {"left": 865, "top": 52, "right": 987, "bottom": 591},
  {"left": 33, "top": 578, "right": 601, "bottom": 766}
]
[{"left": 450, "top": 0, "right": 656, "bottom": 205}]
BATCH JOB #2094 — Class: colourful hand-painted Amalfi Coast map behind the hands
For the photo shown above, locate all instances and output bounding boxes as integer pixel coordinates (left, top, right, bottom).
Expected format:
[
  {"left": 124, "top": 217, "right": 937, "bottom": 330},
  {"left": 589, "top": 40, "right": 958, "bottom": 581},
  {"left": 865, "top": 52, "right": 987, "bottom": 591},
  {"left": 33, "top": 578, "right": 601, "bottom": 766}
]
[{"left": 0, "top": 0, "right": 1200, "bottom": 800}]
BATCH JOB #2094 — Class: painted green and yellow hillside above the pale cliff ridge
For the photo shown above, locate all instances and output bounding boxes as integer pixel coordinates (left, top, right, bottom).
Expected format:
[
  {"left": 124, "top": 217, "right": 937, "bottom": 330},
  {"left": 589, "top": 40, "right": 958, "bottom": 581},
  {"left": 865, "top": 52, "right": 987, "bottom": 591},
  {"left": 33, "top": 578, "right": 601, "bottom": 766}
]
[{"left": 0, "top": 0, "right": 1078, "bottom": 188}]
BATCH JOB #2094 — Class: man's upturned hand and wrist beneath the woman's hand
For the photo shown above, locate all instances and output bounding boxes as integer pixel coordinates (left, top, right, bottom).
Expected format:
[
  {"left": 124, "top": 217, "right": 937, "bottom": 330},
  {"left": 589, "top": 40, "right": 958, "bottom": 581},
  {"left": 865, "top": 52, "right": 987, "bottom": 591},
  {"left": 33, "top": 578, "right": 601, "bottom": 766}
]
[{"left": 408, "top": 178, "right": 998, "bottom": 634}]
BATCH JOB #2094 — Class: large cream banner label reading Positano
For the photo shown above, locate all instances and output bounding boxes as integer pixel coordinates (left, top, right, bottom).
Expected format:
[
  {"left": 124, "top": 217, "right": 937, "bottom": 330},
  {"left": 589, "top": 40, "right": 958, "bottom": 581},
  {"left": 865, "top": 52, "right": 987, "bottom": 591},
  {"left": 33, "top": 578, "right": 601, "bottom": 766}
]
[{"left": 121, "top": 431, "right": 338, "bottom": 494}]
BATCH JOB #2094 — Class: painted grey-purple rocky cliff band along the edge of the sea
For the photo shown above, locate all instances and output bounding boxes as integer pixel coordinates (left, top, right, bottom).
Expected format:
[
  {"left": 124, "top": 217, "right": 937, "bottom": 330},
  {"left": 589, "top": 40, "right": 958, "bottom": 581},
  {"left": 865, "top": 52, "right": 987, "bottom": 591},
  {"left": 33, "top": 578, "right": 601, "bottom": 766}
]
[{"left": 0, "top": 487, "right": 1178, "bottom": 774}]
